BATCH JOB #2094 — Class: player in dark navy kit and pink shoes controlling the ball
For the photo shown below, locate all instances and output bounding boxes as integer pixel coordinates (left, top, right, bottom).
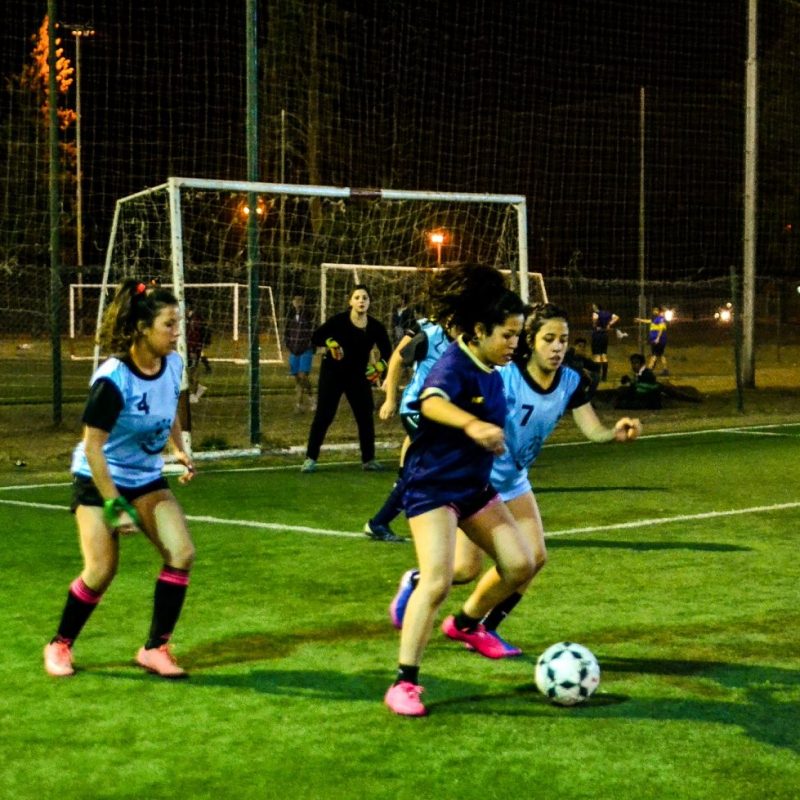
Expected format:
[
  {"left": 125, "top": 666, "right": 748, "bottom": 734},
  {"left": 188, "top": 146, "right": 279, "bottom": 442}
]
[{"left": 385, "top": 265, "right": 534, "bottom": 717}]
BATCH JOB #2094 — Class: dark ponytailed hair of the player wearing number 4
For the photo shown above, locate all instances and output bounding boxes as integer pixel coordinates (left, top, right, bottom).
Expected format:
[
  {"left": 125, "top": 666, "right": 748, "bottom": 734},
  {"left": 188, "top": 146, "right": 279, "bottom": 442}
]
[{"left": 97, "top": 278, "right": 178, "bottom": 355}]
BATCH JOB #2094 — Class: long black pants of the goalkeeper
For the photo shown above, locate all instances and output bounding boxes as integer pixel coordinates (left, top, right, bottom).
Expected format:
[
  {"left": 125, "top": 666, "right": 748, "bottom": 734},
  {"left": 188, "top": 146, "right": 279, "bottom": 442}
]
[{"left": 306, "top": 368, "right": 375, "bottom": 463}]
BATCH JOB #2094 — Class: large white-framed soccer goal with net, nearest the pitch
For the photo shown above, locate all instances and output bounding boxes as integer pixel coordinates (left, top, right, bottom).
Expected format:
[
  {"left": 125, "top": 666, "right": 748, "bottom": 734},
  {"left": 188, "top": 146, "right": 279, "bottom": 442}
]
[{"left": 101, "top": 178, "right": 538, "bottom": 455}]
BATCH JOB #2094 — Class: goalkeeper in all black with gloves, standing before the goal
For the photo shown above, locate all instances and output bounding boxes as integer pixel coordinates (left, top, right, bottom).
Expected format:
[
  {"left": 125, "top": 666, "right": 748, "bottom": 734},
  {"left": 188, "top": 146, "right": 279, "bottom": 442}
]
[{"left": 301, "top": 284, "right": 392, "bottom": 472}]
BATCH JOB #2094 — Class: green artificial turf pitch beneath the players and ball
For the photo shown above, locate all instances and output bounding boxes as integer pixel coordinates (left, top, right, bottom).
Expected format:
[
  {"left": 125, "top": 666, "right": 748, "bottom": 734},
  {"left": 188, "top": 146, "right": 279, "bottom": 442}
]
[{"left": 0, "top": 426, "right": 800, "bottom": 800}]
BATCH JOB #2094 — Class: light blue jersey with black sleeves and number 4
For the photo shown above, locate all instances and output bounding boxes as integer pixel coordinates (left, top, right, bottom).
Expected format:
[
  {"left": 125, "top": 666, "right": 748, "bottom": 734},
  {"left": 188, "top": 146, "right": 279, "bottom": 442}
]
[{"left": 71, "top": 352, "right": 183, "bottom": 488}]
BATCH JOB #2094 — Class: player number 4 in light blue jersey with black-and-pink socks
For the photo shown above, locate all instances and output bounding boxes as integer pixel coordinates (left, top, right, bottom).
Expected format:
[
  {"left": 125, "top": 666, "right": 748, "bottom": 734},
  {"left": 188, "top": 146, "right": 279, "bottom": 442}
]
[{"left": 44, "top": 279, "right": 194, "bottom": 678}]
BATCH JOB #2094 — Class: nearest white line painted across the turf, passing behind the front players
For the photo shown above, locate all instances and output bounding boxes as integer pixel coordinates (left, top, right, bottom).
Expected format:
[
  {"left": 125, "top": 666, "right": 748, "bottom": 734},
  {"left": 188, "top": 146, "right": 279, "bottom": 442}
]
[{"left": 0, "top": 499, "right": 800, "bottom": 539}]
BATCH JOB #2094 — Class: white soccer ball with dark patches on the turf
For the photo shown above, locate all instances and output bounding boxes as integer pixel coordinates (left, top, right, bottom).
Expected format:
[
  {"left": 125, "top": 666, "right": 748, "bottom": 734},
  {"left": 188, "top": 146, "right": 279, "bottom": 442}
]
[{"left": 535, "top": 642, "right": 600, "bottom": 706}]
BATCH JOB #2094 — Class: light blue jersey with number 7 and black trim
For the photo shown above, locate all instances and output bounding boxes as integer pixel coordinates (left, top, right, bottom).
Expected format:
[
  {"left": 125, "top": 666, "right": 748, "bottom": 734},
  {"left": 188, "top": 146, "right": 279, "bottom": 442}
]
[{"left": 491, "top": 363, "right": 591, "bottom": 501}]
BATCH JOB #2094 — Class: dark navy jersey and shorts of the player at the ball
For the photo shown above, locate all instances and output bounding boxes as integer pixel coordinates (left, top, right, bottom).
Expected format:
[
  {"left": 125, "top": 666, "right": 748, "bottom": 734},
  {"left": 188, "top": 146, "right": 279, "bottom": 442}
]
[{"left": 403, "top": 338, "right": 506, "bottom": 516}]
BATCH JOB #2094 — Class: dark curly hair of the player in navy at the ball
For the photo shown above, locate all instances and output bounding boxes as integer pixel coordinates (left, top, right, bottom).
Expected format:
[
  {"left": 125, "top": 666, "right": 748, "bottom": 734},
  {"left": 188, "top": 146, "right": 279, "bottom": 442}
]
[{"left": 430, "top": 264, "right": 525, "bottom": 339}]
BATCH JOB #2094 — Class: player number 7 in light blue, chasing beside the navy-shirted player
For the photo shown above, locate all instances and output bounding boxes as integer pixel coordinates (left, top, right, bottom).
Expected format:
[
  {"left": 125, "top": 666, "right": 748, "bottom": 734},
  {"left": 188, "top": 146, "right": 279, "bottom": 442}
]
[{"left": 389, "top": 303, "right": 641, "bottom": 658}]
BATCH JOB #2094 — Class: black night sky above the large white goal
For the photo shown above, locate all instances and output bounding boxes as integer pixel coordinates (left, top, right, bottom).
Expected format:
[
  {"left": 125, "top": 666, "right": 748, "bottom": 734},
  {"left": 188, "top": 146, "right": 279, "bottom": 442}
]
[{"left": 0, "top": 0, "right": 792, "bottom": 282}]
